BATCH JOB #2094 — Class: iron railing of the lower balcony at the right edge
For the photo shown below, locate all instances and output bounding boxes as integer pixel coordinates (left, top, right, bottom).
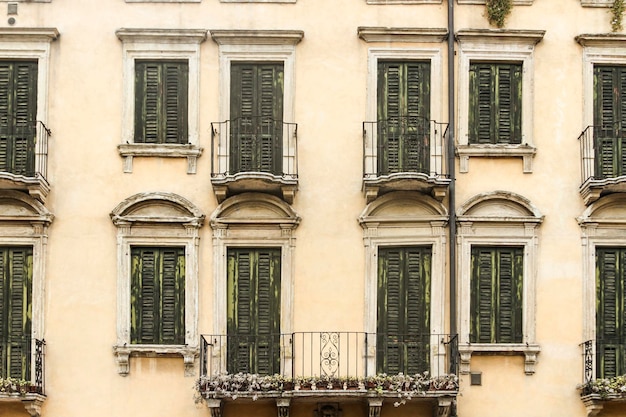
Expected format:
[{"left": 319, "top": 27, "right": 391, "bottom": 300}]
[{"left": 580, "top": 338, "right": 626, "bottom": 390}]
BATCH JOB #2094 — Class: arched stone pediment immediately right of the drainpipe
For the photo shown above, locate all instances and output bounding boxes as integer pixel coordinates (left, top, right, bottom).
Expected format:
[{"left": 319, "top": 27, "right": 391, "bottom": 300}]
[{"left": 457, "top": 191, "right": 543, "bottom": 221}]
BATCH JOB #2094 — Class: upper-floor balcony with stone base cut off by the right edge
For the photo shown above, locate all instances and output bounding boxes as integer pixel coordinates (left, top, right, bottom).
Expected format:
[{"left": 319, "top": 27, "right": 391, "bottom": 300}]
[{"left": 578, "top": 126, "right": 626, "bottom": 205}]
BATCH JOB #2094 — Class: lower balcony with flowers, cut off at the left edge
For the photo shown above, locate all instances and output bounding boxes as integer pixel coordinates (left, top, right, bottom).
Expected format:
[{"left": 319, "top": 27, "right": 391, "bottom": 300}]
[{"left": 0, "top": 339, "right": 46, "bottom": 417}]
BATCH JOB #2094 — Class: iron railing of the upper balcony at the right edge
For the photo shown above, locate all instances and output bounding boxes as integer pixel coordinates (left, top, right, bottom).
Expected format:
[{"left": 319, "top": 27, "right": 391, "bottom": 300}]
[{"left": 578, "top": 126, "right": 626, "bottom": 183}]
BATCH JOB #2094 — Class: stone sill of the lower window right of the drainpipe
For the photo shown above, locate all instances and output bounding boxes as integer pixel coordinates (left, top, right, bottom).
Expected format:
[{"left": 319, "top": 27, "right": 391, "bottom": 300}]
[{"left": 459, "top": 343, "right": 541, "bottom": 375}]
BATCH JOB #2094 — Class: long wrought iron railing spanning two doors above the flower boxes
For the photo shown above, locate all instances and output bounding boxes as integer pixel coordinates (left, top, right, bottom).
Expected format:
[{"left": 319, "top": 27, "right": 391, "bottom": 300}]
[{"left": 200, "top": 331, "right": 458, "bottom": 378}]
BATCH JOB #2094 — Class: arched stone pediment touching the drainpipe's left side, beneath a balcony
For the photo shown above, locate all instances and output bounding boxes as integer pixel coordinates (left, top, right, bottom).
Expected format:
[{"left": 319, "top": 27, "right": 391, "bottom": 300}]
[{"left": 359, "top": 191, "right": 448, "bottom": 223}]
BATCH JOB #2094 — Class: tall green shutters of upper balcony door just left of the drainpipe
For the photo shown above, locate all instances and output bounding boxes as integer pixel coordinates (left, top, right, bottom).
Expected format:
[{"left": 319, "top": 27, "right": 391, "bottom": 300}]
[{"left": 377, "top": 61, "right": 430, "bottom": 175}]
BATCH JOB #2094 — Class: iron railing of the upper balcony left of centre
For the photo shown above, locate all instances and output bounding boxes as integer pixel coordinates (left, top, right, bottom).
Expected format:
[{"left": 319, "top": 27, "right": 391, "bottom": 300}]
[{"left": 211, "top": 117, "right": 298, "bottom": 179}]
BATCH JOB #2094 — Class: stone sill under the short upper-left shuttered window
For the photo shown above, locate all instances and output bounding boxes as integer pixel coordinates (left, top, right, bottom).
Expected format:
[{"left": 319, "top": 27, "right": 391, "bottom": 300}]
[{"left": 117, "top": 143, "right": 202, "bottom": 174}]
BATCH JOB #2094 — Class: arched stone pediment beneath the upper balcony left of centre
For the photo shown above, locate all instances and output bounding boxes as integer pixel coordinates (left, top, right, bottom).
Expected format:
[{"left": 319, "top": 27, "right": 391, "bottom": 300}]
[{"left": 211, "top": 193, "right": 300, "bottom": 226}]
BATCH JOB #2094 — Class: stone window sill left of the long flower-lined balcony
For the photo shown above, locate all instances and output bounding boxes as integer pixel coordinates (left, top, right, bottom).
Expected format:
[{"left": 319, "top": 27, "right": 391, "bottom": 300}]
[{"left": 113, "top": 345, "right": 198, "bottom": 376}]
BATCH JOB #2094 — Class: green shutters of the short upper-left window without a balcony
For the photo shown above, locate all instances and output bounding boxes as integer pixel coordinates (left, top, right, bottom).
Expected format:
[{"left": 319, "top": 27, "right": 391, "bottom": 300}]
[{"left": 135, "top": 61, "right": 189, "bottom": 144}]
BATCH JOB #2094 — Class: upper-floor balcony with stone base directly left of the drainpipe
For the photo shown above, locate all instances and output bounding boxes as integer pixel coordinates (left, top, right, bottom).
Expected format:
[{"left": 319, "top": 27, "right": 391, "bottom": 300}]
[{"left": 363, "top": 117, "right": 450, "bottom": 203}]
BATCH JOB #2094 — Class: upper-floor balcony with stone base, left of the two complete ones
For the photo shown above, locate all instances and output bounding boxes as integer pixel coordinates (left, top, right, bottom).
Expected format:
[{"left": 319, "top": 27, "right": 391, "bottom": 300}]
[{"left": 211, "top": 117, "right": 298, "bottom": 204}]
